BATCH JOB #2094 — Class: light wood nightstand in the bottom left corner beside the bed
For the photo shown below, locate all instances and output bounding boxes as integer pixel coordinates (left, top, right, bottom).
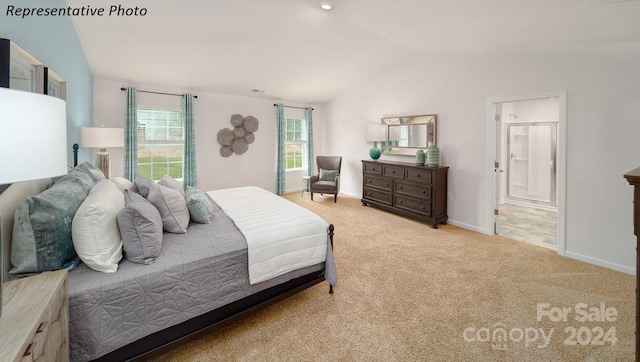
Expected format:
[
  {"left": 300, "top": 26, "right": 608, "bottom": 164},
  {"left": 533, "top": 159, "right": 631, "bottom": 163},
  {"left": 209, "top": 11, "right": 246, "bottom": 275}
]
[{"left": 0, "top": 270, "right": 69, "bottom": 361}]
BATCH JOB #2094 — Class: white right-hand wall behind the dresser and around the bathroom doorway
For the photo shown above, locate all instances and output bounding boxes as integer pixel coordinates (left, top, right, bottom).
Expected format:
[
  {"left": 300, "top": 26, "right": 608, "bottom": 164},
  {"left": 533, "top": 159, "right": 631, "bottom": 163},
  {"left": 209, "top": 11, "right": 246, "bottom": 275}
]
[{"left": 326, "top": 44, "right": 640, "bottom": 273}]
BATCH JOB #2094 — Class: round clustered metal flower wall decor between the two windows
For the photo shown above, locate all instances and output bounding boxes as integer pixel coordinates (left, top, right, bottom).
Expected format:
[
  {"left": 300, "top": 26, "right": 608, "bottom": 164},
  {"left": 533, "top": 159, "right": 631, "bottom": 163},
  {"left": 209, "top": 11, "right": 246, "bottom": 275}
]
[{"left": 218, "top": 114, "right": 260, "bottom": 157}]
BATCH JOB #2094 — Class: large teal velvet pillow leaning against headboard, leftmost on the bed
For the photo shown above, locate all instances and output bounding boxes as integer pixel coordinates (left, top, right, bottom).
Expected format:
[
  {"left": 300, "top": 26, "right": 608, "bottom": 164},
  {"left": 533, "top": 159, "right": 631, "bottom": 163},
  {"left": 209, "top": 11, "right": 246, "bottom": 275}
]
[{"left": 9, "top": 170, "right": 94, "bottom": 278}]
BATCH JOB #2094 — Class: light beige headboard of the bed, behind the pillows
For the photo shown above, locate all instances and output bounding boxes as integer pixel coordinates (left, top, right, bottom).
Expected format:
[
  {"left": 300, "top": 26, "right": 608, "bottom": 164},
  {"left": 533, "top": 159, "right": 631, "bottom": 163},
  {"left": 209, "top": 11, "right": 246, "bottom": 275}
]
[{"left": 0, "top": 179, "right": 51, "bottom": 280}]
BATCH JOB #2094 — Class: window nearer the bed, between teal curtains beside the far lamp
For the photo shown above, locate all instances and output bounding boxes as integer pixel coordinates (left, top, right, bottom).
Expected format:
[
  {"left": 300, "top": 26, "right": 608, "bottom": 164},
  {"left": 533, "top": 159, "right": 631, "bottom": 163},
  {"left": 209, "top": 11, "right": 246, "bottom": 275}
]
[{"left": 138, "top": 109, "right": 184, "bottom": 180}]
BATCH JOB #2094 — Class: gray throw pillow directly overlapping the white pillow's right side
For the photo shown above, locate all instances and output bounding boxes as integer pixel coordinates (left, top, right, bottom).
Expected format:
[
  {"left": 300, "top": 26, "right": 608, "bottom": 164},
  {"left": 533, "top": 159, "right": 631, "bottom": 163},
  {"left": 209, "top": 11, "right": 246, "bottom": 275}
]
[{"left": 118, "top": 190, "right": 162, "bottom": 264}]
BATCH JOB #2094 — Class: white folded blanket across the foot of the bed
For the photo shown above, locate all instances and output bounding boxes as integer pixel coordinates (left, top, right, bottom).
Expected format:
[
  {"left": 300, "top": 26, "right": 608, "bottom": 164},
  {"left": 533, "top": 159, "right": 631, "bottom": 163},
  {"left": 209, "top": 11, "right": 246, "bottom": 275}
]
[{"left": 207, "top": 186, "right": 337, "bottom": 285}]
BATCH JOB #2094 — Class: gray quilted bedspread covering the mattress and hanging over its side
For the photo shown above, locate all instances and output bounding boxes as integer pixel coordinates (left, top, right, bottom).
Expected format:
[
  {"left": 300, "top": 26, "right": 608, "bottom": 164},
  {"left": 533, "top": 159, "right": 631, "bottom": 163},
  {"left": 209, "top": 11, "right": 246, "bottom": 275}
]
[{"left": 68, "top": 199, "right": 324, "bottom": 361}]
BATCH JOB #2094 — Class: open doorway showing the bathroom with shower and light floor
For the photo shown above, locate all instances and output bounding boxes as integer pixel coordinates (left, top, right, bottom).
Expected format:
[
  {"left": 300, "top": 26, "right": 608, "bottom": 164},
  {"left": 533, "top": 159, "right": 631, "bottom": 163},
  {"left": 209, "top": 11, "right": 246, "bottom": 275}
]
[{"left": 490, "top": 93, "right": 566, "bottom": 253}]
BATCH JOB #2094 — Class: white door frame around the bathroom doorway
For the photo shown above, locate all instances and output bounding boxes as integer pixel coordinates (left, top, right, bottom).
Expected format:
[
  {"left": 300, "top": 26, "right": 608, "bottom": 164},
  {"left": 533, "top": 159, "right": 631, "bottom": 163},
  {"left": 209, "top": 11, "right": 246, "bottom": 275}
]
[{"left": 485, "top": 91, "right": 567, "bottom": 256}]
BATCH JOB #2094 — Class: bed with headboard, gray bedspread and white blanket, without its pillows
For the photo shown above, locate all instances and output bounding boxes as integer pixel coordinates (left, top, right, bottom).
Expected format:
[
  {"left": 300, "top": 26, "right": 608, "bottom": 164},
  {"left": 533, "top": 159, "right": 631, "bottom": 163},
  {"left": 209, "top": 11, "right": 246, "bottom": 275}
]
[{"left": 0, "top": 171, "right": 337, "bottom": 361}]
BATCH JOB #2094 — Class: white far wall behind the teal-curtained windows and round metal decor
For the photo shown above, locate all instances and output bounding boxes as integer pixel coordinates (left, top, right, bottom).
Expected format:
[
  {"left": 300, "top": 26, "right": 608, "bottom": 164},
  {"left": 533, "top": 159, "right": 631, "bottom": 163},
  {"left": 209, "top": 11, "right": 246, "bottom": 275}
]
[{"left": 94, "top": 79, "right": 323, "bottom": 191}]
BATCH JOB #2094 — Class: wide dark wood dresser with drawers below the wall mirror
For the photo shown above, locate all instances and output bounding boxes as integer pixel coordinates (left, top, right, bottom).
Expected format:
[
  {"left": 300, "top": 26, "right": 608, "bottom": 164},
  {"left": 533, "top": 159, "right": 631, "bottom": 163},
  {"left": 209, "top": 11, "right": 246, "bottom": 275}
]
[{"left": 362, "top": 160, "right": 449, "bottom": 229}]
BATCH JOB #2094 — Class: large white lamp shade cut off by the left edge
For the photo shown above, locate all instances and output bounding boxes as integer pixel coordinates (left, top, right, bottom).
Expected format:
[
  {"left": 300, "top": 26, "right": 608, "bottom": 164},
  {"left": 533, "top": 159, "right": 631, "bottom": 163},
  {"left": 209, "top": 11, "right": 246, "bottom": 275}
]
[{"left": 0, "top": 88, "right": 67, "bottom": 184}]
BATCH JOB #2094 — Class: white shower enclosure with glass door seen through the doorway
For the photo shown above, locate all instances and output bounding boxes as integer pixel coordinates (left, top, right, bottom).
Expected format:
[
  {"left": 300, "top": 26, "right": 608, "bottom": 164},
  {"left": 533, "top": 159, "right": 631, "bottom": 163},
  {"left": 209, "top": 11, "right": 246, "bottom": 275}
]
[{"left": 506, "top": 122, "right": 557, "bottom": 207}]
